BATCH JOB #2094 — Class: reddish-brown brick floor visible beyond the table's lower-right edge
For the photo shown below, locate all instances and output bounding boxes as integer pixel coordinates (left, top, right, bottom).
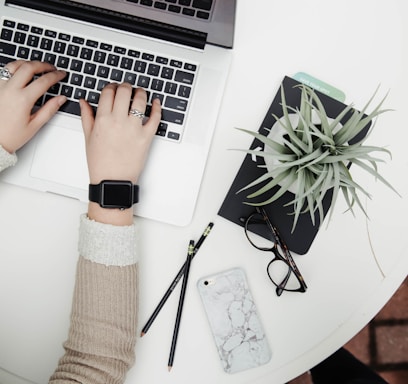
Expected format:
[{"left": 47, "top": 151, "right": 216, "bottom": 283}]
[{"left": 289, "top": 278, "right": 408, "bottom": 384}]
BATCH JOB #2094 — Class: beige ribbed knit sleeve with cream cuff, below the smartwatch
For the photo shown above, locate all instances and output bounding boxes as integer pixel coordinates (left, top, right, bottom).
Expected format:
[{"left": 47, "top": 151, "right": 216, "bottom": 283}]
[{"left": 49, "top": 216, "right": 137, "bottom": 384}]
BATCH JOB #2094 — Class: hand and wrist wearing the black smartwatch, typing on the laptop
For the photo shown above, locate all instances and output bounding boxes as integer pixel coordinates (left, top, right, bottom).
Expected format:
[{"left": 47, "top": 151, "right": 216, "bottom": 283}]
[{"left": 80, "top": 83, "right": 161, "bottom": 225}]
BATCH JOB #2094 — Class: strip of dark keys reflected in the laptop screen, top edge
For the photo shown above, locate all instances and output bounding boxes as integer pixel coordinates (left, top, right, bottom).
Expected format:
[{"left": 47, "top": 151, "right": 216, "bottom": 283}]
[{"left": 126, "top": 0, "right": 213, "bottom": 20}]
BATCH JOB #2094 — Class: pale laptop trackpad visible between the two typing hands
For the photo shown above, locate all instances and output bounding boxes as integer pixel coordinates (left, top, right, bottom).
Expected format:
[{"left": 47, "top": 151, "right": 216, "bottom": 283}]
[{"left": 30, "top": 124, "right": 89, "bottom": 189}]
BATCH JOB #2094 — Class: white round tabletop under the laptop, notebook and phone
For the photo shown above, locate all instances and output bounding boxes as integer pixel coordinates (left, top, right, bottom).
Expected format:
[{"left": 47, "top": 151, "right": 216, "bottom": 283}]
[{"left": 0, "top": 0, "right": 408, "bottom": 384}]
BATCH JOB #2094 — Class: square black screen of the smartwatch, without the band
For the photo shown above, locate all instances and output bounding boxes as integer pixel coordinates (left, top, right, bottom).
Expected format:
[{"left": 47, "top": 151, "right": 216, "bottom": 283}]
[{"left": 101, "top": 181, "right": 133, "bottom": 208}]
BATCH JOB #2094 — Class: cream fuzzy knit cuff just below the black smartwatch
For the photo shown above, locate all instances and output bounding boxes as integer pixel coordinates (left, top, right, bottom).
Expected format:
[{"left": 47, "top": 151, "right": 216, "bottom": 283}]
[{"left": 78, "top": 214, "right": 138, "bottom": 267}]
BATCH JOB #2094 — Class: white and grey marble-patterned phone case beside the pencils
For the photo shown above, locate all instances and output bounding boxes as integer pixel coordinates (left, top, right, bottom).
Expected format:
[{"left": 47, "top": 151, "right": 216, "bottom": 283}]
[{"left": 197, "top": 268, "right": 271, "bottom": 373}]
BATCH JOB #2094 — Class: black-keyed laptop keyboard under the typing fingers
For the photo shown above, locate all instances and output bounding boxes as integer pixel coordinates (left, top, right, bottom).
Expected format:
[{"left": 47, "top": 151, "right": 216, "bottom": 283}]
[{"left": 0, "top": 19, "right": 198, "bottom": 142}]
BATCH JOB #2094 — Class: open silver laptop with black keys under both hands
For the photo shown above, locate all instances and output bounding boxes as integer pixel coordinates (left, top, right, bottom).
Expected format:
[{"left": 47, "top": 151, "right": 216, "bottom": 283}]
[{"left": 0, "top": 0, "right": 236, "bottom": 226}]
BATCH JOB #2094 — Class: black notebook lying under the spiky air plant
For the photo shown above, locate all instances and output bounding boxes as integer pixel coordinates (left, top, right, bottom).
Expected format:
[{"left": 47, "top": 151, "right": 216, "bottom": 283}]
[{"left": 218, "top": 76, "right": 369, "bottom": 255}]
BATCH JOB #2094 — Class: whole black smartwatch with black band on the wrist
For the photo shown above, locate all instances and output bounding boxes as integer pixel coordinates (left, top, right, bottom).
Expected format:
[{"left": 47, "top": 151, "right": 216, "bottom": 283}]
[{"left": 89, "top": 180, "right": 139, "bottom": 210}]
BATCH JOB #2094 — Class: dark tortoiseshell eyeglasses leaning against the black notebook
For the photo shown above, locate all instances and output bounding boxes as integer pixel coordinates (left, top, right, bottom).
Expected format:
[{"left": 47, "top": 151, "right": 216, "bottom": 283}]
[{"left": 241, "top": 207, "right": 307, "bottom": 296}]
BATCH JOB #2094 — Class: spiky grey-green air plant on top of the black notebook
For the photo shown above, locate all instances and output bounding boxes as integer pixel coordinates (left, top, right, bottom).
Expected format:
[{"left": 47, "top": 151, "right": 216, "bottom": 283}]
[{"left": 236, "top": 85, "right": 398, "bottom": 231}]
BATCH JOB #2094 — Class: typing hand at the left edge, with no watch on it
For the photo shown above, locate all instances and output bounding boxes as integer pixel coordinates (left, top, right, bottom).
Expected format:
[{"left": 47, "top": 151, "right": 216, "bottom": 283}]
[{"left": 0, "top": 60, "right": 66, "bottom": 153}]
